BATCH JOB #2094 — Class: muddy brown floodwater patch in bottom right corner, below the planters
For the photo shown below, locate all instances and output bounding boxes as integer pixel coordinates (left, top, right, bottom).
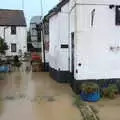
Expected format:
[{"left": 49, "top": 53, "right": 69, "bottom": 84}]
[{"left": 89, "top": 96, "right": 120, "bottom": 120}]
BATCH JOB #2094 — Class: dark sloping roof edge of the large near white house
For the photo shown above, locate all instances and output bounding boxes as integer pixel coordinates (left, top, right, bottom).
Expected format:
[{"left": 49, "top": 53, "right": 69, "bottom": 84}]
[{"left": 45, "top": 0, "right": 70, "bottom": 19}]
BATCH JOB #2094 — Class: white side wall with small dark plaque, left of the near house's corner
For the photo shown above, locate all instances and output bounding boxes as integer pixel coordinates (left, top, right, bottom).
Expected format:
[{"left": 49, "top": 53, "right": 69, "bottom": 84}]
[{"left": 49, "top": 4, "right": 69, "bottom": 71}]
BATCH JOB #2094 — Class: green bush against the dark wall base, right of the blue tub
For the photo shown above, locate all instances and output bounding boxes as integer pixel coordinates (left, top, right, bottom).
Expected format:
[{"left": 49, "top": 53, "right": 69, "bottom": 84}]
[{"left": 103, "top": 84, "right": 119, "bottom": 99}]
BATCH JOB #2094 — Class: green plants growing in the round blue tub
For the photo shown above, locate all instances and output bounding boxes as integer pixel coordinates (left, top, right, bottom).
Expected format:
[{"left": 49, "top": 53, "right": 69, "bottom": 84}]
[{"left": 80, "top": 82, "right": 99, "bottom": 94}]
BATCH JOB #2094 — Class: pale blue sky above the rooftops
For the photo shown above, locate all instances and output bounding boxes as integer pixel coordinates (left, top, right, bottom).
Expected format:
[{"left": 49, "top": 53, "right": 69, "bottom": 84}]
[{"left": 0, "top": 0, "right": 59, "bottom": 23}]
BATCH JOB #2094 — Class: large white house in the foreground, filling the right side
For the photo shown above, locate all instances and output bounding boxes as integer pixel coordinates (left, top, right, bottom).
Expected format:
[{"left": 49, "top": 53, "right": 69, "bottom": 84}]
[{"left": 49, "top": 0, "right": 120, "bottom": 90}]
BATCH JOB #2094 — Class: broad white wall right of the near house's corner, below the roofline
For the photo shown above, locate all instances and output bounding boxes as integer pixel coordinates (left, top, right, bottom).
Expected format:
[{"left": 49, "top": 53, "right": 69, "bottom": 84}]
[{"left": 72, "top": 5, "right": 120, "bottom": 80}]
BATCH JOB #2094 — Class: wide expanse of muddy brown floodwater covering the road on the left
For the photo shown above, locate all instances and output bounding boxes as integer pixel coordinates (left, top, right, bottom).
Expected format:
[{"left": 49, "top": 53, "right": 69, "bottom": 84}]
[{"left": 0, "top": 63, "right": 82, "bottom": 120}]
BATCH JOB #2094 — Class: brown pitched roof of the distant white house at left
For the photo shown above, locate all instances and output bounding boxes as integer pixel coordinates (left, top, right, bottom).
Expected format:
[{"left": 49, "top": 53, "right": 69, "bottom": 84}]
[{"left": 0, "top": 9, "right": 26, "bottom": 26}]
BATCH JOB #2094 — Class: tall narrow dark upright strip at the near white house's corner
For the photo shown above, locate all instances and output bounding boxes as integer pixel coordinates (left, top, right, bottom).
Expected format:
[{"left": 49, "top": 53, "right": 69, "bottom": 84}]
[{"left": 71, "top": 32, "right": 74, "bottom": 75}]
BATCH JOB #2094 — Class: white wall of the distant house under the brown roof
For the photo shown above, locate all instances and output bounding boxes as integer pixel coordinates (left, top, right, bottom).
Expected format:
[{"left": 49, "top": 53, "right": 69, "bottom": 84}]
[{"left": 0, "top": 26, "right": 27, "bottom": 56}]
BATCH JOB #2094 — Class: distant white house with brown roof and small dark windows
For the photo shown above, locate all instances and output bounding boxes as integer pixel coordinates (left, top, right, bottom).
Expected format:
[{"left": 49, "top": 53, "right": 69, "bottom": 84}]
[{"left": 0, "top": 9, "right": 27, "bottom": 56}]
